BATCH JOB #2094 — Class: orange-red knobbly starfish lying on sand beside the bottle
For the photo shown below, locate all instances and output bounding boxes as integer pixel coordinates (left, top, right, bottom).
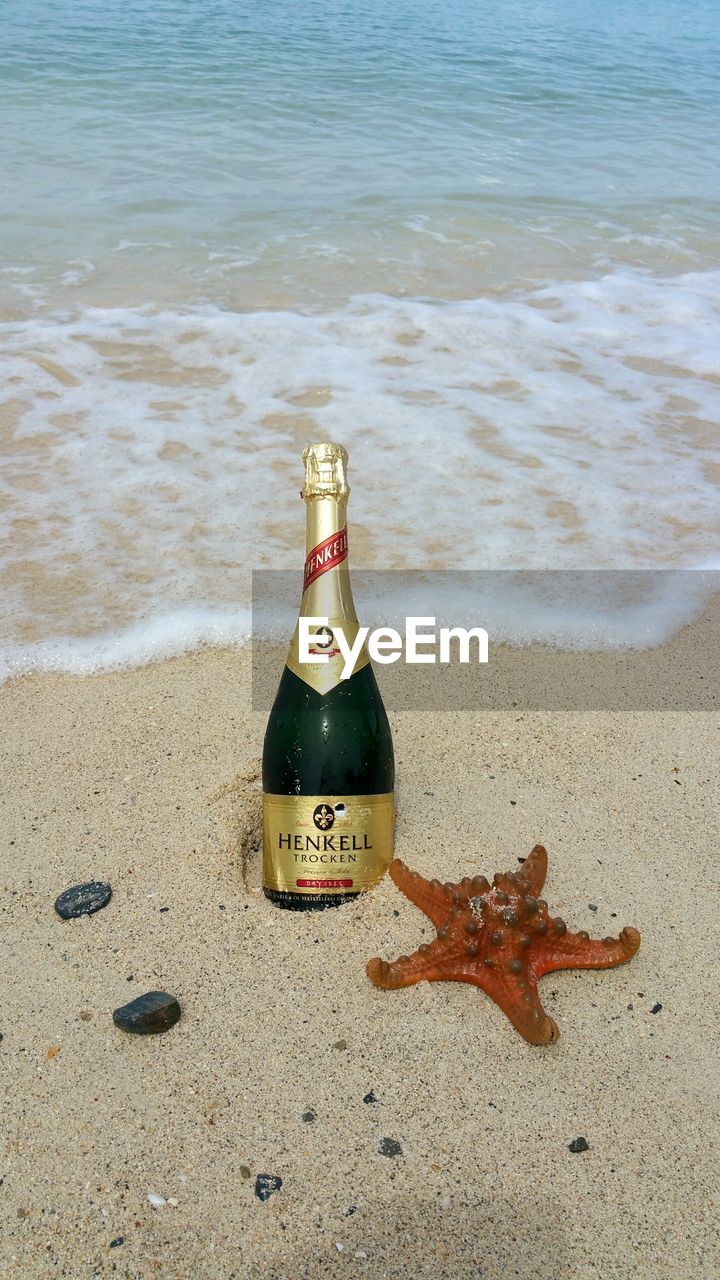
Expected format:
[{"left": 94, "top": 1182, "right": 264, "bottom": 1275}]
[{"left": 366, "top": 845, "right": 641, "bottom": 1044}]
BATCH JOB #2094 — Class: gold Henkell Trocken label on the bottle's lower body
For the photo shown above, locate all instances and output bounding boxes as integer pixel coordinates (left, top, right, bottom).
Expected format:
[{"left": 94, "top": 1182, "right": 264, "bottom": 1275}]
[{"left": 263, "top": 791, "right": 395, "bottom": 897}]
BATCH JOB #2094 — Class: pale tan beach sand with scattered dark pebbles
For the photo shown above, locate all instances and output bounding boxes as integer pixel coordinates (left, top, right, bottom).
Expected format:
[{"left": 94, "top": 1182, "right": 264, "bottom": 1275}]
[{"left": 0, "top": 614, "right": 720, "bottom": 1280}]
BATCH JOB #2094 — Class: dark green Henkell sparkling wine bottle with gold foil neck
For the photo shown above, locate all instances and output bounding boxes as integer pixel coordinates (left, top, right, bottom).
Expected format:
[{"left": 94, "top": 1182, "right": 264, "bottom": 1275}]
[{"left": 263, "top": 443, "right": 395, "bottom": 911}]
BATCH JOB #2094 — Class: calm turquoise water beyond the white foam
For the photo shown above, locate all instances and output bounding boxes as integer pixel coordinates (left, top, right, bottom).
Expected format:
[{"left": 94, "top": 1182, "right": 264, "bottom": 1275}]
[{"left": 0, "top": 0, "right": 720, "bottom": 306}]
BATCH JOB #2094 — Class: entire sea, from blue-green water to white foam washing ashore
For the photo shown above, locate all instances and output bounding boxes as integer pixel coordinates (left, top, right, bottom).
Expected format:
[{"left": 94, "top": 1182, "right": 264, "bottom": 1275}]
[{"left": 0, "top": 0, "right": 720, "bottom": 676}]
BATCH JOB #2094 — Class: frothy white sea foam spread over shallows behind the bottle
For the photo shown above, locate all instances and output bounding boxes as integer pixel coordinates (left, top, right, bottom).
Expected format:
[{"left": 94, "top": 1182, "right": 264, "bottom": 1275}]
[{"left": 0, "top": 264, "right": 720, "bottom": 672}]
